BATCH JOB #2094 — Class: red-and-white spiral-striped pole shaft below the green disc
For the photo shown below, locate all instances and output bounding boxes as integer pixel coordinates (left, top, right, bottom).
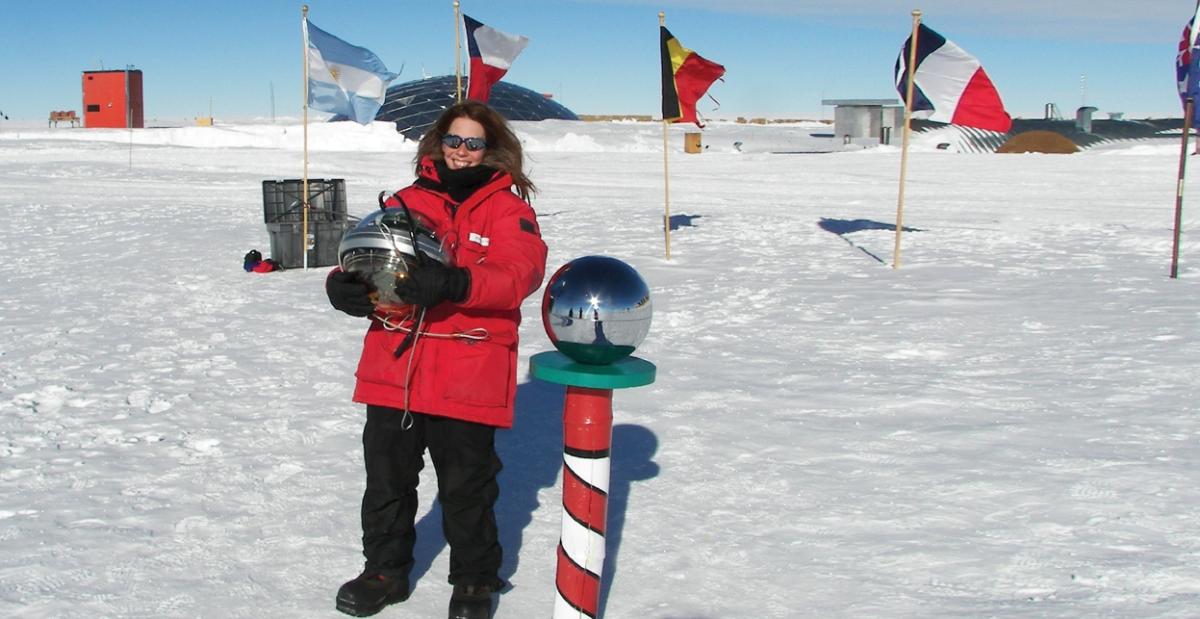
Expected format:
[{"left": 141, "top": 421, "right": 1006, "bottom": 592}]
[{"left": 554, "top": 386, "right": 612, "bottom": 619}]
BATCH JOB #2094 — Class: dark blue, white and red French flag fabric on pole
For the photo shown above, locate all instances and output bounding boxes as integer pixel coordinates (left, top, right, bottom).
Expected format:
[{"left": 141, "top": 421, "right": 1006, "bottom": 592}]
[{"left": 895, "top": 24, "right": 1013, "bottom": 133}]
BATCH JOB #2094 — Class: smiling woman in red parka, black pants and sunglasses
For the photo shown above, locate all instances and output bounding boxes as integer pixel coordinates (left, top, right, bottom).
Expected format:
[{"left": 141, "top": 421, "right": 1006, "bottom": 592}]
[{"left": 325, "top": 101, "right": 546, "bottom": 618}]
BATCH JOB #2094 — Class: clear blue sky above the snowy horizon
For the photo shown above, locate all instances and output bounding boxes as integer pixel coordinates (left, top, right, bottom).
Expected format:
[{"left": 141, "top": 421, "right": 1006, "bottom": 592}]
[{"left": 0, "top": 0, "right": 1195, "bottom": 125}]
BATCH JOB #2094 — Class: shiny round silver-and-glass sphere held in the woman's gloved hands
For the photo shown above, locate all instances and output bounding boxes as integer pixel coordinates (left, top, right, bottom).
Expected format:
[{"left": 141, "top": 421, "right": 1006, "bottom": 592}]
[{"left": 337, "top": 208, "right": 448, "bottom": 311}]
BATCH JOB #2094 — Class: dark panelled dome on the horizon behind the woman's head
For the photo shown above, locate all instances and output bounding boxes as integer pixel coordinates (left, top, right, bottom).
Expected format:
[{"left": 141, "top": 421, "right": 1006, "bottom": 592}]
[{"left": 330, "top": 76, "right": 580, "bottom": 140}]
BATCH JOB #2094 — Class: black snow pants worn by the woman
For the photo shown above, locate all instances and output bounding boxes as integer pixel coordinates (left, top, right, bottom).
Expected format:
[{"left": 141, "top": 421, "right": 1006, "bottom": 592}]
[{"left": 362, "top": 404, "right": 502, "bottom": 588}]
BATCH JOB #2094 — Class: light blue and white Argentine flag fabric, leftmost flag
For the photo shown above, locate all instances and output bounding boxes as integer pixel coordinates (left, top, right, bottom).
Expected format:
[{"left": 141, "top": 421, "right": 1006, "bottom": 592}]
[{"left": 305, "top": 19, "right": 396, "bottom": 125}]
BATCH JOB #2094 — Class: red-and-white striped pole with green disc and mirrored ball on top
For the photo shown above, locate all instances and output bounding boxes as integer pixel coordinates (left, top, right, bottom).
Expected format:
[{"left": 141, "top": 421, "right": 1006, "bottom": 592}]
[{"left": 529, "top": 256, "right": 656, "bottom": 619}]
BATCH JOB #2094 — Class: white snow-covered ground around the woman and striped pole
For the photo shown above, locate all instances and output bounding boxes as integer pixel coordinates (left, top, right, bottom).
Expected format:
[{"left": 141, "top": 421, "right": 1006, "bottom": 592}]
[{"left": 0, "top": 121, "right": 1200, "bottom": 619}]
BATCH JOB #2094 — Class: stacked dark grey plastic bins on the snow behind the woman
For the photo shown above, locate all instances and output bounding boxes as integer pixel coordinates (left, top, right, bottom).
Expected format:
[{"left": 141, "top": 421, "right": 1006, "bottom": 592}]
[{"left": 263, "top": 179, "right": 352, "bottom": 269}]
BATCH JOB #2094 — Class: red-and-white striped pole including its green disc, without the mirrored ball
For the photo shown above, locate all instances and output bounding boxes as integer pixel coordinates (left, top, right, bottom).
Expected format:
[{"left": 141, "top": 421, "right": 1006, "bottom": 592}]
[{"left": 529, "top": 351, "right": 656, "bottom": 619}]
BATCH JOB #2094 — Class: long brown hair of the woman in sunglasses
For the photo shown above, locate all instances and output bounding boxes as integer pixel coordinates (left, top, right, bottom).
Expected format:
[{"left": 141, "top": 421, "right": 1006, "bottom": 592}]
[{"left": 415, "top": 101, "right": 538, "bottom": 202}]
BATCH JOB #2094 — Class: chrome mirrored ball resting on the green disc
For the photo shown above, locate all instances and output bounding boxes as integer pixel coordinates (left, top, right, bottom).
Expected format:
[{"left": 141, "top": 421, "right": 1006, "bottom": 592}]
[{"left": 541, "top": 256, "right": 653, "bottom": 365}]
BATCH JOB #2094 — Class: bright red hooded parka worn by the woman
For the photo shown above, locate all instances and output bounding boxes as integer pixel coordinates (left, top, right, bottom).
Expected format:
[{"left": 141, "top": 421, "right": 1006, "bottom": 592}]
[{"left": 354, "top": 158, "right": 546, "bottom": 428}]
